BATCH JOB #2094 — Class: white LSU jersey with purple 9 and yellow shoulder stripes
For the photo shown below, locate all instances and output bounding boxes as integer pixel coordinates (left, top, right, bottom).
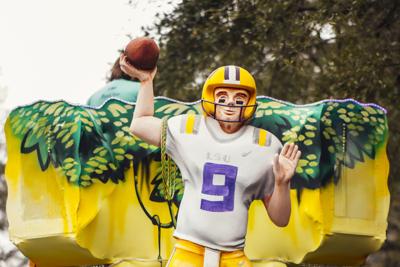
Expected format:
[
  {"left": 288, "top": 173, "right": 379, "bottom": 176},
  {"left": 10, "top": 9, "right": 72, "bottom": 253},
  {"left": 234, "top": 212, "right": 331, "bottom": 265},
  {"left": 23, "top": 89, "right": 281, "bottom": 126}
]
[{"left": 167, "top": 115, "right": 282, "bottom": 251}]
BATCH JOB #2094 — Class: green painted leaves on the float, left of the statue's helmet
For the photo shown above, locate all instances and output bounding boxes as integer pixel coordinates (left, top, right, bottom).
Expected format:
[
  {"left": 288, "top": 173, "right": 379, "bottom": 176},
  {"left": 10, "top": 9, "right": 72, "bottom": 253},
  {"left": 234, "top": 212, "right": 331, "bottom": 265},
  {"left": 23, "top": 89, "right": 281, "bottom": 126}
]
[{"left": 8, "top": 97, "right": 200, "bottom": 197}]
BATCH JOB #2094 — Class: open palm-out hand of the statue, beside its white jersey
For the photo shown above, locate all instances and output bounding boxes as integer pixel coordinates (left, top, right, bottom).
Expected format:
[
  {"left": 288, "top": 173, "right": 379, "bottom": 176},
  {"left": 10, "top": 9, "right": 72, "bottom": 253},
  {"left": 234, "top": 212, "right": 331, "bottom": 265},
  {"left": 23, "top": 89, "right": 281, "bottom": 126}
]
[{"left": 273, "top": 143, "right": 301, "bottom": 185}]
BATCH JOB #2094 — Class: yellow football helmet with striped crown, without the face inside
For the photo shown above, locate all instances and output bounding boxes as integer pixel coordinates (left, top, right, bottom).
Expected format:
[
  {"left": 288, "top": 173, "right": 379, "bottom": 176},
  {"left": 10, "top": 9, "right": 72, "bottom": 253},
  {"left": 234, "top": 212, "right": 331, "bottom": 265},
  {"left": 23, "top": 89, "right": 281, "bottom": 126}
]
[{"left": 201, "top": 65, "right": 257, "bottom": 122}]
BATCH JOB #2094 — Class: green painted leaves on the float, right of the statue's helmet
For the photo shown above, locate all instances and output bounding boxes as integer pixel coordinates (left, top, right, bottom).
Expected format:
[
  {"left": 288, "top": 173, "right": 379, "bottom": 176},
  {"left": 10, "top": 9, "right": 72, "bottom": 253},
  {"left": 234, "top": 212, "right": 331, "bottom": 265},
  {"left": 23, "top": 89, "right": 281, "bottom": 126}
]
[{"left": 251, "top": 97, "right": 388, "bottom": 192}]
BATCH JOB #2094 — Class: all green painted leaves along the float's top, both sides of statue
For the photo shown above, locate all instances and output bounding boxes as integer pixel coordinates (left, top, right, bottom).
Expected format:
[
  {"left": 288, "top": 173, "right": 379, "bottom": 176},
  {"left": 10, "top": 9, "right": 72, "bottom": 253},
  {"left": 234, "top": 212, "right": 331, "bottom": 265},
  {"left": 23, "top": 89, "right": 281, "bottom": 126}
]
[{"left": 9, "top": 97, "right": 388, "bottom": 195}]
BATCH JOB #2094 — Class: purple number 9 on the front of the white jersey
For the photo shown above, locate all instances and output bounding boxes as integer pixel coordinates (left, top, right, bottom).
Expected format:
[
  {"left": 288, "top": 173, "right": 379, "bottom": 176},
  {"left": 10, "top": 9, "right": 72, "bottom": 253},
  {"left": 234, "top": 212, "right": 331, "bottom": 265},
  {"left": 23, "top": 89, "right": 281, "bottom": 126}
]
[{"left": 200, "top": 162, "right": 238, "bottom": 212}]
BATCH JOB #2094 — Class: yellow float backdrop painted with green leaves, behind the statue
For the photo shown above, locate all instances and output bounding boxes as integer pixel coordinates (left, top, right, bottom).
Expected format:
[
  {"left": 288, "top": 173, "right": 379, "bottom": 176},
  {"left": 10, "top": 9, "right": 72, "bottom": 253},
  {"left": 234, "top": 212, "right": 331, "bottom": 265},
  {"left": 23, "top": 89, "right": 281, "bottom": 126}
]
[{"left": 5, "top": 97, "right": 390, "bottom": 266}]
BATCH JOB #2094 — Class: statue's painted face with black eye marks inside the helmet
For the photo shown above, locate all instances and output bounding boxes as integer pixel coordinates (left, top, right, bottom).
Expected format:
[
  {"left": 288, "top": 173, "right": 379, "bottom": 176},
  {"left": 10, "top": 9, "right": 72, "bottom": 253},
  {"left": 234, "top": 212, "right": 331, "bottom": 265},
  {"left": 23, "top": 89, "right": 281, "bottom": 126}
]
[{"left": 214, "top": 88, "right": 249, "bottom": 122}]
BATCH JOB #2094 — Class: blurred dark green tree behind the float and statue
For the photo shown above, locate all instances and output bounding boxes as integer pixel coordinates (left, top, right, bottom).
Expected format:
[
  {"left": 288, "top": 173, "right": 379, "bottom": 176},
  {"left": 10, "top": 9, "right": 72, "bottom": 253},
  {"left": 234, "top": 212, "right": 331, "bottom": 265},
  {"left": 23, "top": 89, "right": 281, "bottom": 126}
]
[{"left": 144, "top": 0, "right": 400, "bottom": 266}]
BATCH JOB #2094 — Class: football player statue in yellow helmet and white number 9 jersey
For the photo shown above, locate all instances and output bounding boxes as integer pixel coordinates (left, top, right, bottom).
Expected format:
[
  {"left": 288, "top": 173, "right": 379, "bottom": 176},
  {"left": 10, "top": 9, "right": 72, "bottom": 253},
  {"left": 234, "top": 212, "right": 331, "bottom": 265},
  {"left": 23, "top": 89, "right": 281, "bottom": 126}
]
[{"left": 120, "top": 56, "right": 301, "bottom": 267}]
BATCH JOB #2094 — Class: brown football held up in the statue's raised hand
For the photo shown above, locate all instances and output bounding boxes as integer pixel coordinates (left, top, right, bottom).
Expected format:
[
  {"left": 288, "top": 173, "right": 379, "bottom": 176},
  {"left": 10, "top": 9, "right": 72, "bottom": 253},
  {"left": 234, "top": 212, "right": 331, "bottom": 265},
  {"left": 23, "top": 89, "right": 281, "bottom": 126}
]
[{"left": 125, "top": 37, "right": 160, "bottom": 70}]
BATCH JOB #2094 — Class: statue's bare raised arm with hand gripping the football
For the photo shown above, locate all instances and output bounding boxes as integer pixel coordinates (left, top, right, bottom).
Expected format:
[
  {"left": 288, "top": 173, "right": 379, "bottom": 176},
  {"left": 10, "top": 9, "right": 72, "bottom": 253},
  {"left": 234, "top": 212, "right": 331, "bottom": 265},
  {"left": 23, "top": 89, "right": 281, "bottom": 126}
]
[{"left": 120, "top": 55, "right": 161, "bottom": 146}]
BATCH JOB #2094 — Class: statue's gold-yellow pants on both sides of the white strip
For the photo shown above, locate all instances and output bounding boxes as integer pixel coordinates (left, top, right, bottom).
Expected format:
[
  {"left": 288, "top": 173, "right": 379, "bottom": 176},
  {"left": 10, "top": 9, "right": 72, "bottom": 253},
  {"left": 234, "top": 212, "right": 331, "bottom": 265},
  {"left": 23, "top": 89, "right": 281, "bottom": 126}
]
[{"left": 167, "top": 240, "right": 252, "bottom": 267}]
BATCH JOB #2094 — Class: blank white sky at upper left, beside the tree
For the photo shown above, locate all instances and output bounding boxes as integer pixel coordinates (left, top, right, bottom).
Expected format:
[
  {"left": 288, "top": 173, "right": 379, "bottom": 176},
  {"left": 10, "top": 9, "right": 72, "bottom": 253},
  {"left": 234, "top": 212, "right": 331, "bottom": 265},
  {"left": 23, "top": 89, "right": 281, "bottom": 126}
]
[{"left": 0, "top": 0, "right": 179, "bottom": 108}]
